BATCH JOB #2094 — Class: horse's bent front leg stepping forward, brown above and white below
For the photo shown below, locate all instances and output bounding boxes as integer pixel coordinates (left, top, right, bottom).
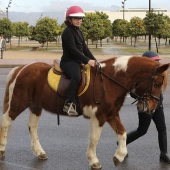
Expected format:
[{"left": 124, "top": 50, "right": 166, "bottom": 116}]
[{"left": 108, "top": 115, "right": 127, "bottom": 166}]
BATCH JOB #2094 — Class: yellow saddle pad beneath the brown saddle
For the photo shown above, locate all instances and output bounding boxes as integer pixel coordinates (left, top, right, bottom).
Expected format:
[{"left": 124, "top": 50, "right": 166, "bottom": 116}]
[{"left": 47, "top": 65, "right": 90, "bottom": 96}]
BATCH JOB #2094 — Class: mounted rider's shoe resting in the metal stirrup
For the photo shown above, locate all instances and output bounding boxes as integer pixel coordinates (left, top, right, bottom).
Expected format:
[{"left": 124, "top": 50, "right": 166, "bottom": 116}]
[{"left": 63, "top": 103, "right": 78, "bottom": 116}]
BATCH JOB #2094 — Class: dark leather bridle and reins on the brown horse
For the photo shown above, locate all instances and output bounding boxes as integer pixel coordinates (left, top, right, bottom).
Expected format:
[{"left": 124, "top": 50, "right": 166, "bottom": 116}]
[{"left": 93, "top": 62, "right": 163, "bottom": 104}]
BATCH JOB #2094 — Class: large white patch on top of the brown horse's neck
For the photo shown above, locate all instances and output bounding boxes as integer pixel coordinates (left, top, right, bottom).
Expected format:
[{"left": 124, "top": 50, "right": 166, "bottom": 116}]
[{"left": 113, "top": 56, "right": 132, "bottom": 72}]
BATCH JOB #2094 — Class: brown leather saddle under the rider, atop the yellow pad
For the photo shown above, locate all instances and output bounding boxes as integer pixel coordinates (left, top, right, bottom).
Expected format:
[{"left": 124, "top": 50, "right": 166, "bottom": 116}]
[{"left": 53, "top": 60, "right": 87, "bottom": 97}]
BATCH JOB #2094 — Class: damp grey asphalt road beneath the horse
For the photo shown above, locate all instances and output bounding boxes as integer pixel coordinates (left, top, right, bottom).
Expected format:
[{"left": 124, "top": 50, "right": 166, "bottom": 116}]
[{"left": 0, "top": 68, "right": 170, "bottom": 170}]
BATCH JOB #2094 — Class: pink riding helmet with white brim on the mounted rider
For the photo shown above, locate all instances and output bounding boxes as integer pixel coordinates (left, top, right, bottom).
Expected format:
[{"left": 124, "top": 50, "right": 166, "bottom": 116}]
[{"left": 66, "top": 6, "right": 85, "bottom": 17}]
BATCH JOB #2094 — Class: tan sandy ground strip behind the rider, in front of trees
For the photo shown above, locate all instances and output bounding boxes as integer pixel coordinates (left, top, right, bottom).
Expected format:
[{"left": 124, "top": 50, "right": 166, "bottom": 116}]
[{"left": 0, "top": 50, "right": 170, "bottom": 68}]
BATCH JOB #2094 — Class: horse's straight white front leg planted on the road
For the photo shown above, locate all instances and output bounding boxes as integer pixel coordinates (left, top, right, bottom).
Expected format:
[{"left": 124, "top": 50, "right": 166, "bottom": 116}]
[{"left": 87, "top": 116, "right": 102, "bottom": 170}]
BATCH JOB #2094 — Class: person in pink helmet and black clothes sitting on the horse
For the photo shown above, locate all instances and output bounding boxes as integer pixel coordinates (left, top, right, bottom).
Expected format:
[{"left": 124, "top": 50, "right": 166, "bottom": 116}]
[{"left": 60, "top": 6, "right": 96, "bottom": 116}]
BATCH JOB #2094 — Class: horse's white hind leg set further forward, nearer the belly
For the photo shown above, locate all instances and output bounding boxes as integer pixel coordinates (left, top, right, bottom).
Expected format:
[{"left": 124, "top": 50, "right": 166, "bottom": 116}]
[{"left": 28, "top": 108, "right": 48, "bottom": 159}]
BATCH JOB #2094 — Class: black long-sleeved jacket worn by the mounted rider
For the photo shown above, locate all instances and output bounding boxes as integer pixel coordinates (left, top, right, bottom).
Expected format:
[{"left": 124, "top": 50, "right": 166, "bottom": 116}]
[{"left": 60, "top": 26, "right": 96, "bottom": 65}]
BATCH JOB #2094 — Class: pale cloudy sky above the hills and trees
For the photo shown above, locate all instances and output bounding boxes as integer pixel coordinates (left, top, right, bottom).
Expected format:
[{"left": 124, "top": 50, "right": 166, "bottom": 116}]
[{"left": 0, "top": 0, "right": 170, "bottom": 12}]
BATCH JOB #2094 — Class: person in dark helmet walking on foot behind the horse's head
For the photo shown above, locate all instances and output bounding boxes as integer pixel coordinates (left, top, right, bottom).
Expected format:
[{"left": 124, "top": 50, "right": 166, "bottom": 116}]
[{"left": 126, "top": 51, "right": 170, "bottom": 164}]
